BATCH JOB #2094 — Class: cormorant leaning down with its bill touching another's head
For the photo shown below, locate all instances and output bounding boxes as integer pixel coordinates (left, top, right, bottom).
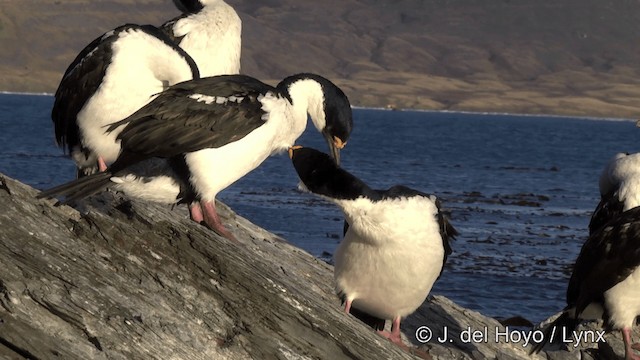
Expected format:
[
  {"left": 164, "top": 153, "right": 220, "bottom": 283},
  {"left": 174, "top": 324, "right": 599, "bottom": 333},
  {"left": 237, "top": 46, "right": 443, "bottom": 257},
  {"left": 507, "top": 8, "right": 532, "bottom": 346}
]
[{"left": 39, "top": 73, "right": 353, "bottom": 238}]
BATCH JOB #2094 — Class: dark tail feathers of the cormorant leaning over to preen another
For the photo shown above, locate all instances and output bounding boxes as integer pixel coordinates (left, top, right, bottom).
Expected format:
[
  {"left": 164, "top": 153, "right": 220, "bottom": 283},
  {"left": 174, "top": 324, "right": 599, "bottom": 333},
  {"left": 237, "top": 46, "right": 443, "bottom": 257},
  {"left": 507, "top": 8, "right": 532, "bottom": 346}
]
[{"left": 36, "top": 171, "right": 113, "bottom": 204}]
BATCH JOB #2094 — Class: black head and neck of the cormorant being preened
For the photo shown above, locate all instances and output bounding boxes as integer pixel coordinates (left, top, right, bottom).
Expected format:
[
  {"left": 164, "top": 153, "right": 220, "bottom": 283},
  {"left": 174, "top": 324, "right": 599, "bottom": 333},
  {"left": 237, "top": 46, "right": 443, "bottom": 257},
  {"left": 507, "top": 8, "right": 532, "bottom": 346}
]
[{"left": 289, "top": 146, "right": 379, "bottom": 200}]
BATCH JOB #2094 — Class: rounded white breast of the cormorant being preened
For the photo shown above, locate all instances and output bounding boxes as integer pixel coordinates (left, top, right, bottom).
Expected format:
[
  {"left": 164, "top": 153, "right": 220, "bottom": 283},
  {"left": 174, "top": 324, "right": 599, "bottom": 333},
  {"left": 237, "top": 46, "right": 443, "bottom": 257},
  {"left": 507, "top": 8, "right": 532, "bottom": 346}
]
[{"left": 335, "top": 197, "right": 444, "bottom": 319}]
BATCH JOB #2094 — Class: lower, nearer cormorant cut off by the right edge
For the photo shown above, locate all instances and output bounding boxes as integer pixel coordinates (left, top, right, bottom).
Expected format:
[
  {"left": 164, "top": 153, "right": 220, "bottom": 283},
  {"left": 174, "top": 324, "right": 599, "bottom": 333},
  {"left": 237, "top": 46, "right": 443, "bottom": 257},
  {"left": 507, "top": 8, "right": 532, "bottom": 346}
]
[{"left": 533, "top": 207, "right": 640, "bottom": 360}]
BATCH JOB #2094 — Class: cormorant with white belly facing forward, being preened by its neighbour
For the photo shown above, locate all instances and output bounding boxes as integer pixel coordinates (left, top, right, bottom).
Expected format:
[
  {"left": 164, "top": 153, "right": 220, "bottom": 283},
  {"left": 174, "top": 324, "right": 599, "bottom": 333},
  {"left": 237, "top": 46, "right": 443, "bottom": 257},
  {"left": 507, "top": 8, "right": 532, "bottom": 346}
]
[{"left": 289, "top": 146, "right": 457, "bottom": 345}]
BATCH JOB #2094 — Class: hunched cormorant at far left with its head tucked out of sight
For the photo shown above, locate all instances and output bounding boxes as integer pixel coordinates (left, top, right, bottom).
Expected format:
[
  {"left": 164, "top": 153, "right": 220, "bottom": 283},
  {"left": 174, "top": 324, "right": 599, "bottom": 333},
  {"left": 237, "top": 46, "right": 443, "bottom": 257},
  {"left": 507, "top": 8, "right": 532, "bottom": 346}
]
[{"left": 51, "top": 24, "right": 199, "bottom": 176}]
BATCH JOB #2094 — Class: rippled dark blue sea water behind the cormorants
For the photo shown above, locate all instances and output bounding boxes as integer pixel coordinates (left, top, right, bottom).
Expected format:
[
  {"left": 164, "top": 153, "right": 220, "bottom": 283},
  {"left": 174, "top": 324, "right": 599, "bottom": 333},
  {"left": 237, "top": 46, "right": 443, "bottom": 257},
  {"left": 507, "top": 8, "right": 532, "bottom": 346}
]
[{"left": 0, "top": 94, "right": 640, "bottom": 322}]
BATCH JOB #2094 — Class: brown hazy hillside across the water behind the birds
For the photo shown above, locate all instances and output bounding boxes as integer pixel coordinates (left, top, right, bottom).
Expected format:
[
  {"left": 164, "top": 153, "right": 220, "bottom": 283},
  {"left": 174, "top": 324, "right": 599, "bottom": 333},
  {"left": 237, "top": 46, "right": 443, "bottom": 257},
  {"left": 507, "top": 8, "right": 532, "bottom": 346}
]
[{"left": 0, "top": 0, "right": 640, "bottom": 118}]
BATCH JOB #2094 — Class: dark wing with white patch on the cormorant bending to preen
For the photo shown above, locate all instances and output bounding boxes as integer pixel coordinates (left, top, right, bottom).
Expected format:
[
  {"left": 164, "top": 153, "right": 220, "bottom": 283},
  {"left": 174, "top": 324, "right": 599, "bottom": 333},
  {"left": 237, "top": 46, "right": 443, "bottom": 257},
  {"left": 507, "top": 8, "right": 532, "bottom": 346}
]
[{"left": 107, "top": 75, "right": 276, "bottom": 158}]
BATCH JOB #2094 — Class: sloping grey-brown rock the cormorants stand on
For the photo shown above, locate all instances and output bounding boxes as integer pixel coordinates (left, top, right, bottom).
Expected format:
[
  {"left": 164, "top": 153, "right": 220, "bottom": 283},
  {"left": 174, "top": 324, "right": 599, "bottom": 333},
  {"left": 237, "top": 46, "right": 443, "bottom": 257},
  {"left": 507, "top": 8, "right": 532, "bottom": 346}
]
[{"left": 0, "top": 176, "right": 632, "bottom": 359}]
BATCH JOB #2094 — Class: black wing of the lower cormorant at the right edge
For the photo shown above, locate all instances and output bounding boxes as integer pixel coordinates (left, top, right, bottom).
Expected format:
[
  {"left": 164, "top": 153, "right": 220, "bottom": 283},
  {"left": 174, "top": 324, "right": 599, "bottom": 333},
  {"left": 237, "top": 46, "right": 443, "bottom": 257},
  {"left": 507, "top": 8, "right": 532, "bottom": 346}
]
[{"left": 567, "top": 207, "right": 640, "bottom": 314}]
